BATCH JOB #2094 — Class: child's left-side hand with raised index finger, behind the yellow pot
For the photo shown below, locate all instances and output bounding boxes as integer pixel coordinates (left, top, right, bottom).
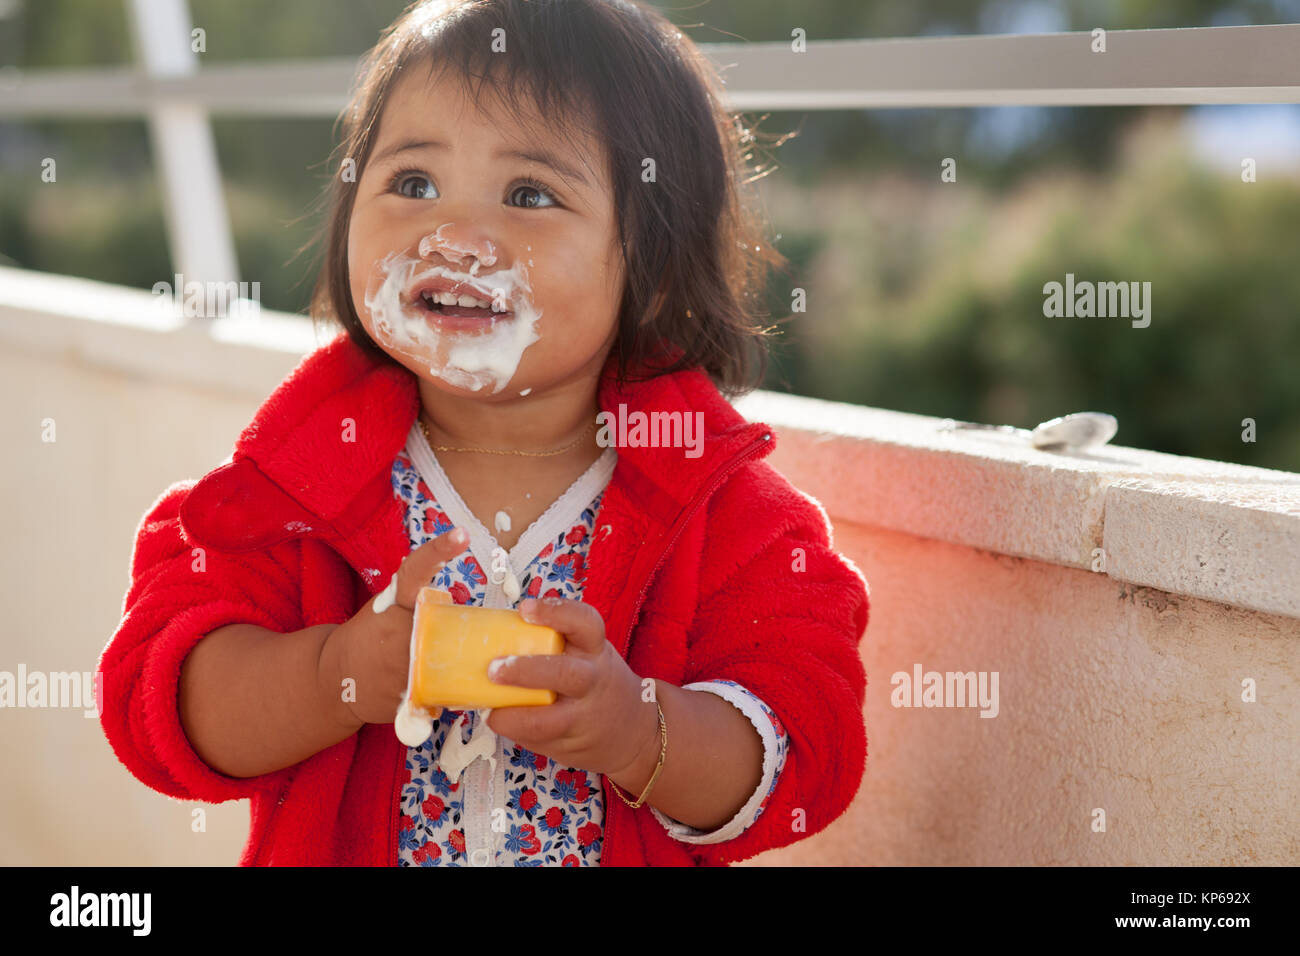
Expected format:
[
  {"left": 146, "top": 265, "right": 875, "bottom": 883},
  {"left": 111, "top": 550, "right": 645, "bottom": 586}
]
[{"left": 322, "top": 528, "right": 469, "bottom": 723}]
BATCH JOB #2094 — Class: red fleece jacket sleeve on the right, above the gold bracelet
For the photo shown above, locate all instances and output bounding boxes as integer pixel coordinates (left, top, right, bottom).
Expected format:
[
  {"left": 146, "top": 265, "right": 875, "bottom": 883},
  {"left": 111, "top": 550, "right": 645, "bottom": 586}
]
[{"left": 684, "top": 466, "right": 870, "bottom": 865}]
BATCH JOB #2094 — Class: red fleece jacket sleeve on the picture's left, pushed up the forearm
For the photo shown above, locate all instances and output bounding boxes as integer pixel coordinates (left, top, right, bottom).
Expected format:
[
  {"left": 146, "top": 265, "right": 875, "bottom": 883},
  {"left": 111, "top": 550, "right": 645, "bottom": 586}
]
[{"left": 99, "top": 481, "right": 302, "bottom": 803}]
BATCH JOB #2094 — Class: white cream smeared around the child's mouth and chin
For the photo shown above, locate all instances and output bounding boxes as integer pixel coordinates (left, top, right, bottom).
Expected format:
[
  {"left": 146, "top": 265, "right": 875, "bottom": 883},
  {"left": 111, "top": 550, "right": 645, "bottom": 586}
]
[{"left": 365, "top": 230, "right": 542, "bottom": 394}]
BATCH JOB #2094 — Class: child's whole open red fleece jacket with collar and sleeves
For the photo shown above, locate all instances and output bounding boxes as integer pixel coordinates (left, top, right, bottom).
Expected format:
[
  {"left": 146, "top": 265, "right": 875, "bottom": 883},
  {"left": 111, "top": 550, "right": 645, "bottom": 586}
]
[{"left": 100, "top": 336, "right": 868, "bottom": 866}]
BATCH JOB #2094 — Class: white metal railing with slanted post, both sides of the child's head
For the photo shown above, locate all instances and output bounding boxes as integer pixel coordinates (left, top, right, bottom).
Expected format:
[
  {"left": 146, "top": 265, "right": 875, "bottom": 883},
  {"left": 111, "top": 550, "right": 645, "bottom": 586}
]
[{"left": 0, "top": 0, "right": 1300, "bottom": 291}]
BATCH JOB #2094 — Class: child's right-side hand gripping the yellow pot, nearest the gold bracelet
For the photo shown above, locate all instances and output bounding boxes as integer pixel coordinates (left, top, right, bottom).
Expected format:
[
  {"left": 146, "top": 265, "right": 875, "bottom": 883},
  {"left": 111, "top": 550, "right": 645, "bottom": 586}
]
[{"left": 488, "top": 597, "right": 658, "bottom": 775}]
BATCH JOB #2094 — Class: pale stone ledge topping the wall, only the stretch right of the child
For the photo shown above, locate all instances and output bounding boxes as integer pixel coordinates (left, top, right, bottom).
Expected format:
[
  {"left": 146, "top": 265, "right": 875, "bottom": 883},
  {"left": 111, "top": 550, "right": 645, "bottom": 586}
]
[{"left": 736, "top": 392, "right": 1300, "bottom": 618}]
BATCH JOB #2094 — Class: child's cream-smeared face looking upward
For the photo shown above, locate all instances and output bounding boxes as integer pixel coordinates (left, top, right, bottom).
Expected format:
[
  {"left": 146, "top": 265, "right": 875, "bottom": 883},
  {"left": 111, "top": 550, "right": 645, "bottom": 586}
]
[{"left": 347, "top": 70, "right": 623, "bottom": 399}]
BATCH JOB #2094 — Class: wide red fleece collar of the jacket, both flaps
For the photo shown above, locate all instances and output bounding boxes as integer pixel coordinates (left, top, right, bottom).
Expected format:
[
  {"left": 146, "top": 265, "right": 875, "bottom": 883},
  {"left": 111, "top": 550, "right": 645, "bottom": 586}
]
[{"left": 181, "top": 333, "right": 776, "bottom": 551}]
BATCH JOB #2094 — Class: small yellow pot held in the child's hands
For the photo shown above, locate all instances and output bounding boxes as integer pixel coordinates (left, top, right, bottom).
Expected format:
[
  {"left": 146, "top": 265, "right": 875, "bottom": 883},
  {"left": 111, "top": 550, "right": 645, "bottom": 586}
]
[{"left": 411, "top": 588, "right": 564, "bottom": 710}]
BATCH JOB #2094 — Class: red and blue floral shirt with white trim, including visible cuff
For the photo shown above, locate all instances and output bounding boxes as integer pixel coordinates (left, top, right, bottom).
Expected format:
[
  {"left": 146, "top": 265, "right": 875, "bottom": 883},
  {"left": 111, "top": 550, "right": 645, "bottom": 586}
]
[{"left": 393, "top": 427, "right": 789, "bottom": 866}]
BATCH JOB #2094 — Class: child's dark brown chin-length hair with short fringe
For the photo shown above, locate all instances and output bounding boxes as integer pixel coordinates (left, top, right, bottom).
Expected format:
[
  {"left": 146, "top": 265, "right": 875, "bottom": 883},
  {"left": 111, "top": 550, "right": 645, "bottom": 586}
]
[{"left": 311, "top": 0, "right": 788, "bottom": 398}]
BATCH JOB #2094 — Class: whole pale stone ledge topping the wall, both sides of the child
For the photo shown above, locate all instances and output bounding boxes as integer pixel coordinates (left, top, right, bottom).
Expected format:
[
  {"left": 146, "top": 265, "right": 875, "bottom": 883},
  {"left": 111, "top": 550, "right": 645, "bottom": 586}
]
[{"left": 0, "top": 268, "right": 1300, "bottom": 618}]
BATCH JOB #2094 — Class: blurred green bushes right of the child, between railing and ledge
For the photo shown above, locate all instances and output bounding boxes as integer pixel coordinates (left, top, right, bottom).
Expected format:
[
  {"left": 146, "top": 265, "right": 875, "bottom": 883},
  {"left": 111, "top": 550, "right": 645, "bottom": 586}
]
[{"left": 774, "top": 115, "right": 1300, "bottom": 470}]
